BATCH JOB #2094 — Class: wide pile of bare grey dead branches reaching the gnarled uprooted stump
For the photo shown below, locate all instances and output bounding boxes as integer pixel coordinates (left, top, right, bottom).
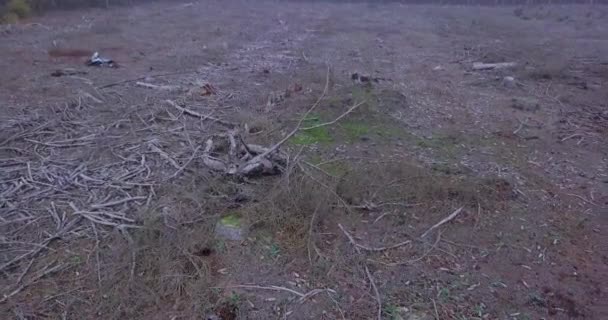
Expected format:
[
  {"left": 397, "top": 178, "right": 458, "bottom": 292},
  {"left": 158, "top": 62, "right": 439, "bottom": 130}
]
[{"left": 0, "top": 65, "right": 361, "bottom": 312}]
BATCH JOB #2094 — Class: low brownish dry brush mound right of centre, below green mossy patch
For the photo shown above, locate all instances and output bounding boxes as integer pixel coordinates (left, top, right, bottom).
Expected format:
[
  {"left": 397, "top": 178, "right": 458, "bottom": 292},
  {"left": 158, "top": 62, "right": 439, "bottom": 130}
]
[{"left": 337, "top": 162, "right": 512, "bottom": 214}]
